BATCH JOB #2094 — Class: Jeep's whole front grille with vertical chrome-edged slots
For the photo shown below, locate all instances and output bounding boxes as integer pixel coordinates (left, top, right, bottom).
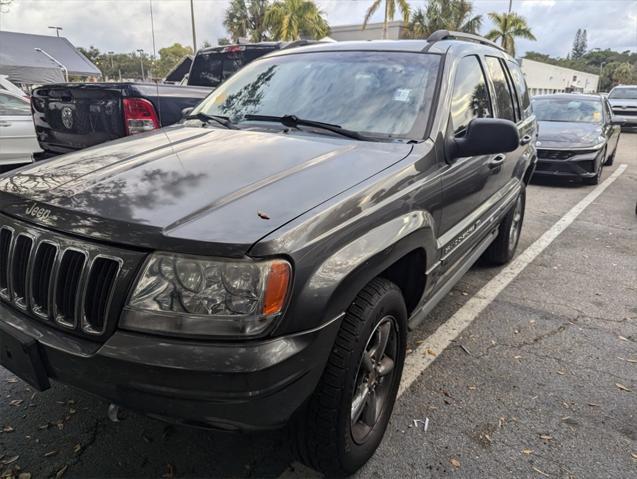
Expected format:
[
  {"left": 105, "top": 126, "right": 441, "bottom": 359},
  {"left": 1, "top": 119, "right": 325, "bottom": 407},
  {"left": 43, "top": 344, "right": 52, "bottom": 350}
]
[{"left": 0, "top": 215, "right": 144, "bottom": 339}]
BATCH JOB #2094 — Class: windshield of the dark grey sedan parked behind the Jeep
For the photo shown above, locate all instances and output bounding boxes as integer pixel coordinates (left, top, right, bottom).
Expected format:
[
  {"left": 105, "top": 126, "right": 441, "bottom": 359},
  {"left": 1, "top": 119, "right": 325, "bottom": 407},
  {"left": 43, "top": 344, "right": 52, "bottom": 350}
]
[{"left": 533, "top": 98, "right": 602, "bottom": 123}]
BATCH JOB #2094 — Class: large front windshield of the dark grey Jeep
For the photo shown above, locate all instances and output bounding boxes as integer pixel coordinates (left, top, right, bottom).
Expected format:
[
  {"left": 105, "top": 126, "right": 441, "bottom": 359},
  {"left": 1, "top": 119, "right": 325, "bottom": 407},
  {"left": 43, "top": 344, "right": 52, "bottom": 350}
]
[{"left": 193, "top": 51, "right": 440, "bottom": 138}]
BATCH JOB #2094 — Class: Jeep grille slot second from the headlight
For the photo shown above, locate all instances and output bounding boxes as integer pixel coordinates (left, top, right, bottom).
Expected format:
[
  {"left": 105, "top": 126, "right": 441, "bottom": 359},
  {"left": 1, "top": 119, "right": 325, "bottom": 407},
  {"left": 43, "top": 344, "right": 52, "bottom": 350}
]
[{"left": 55, "top": 249, "right": 86, "bottom": 327}]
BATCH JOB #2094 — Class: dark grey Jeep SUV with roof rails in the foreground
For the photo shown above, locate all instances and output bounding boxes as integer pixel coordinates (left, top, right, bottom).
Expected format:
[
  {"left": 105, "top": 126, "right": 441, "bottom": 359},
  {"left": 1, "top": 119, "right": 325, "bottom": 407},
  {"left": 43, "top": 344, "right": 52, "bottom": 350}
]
[{"left": 0, "top": 31, "right": 536, "bottom": 475}]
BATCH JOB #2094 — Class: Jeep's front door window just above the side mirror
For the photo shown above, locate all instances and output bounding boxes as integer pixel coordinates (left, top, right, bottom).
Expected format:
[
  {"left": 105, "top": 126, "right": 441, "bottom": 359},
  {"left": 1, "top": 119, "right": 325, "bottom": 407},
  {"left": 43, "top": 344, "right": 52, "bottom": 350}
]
[{"left": 451, "top": 56, "right": 492, "bottom": 134}]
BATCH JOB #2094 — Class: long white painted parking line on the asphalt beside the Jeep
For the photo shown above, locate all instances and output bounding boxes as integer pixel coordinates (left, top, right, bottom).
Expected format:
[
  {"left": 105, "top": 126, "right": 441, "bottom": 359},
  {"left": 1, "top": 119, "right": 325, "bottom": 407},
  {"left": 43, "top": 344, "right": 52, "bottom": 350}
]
[{"left": 398, "top": 164, "right": 627, "bottom": 397}]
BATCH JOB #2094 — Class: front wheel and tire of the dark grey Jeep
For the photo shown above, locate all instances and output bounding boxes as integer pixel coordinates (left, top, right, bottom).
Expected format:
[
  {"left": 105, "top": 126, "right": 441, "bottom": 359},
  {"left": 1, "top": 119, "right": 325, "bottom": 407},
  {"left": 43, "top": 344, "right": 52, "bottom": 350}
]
[{"left": 291, "top": 278, "right": 407, "bottom": 477}]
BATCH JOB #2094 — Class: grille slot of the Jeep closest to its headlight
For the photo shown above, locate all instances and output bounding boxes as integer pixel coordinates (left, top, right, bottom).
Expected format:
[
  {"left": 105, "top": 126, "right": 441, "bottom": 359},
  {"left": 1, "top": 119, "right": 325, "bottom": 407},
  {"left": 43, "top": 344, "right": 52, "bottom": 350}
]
[{"left": 82, "top": 257, "right": 120, "bottom": 334}]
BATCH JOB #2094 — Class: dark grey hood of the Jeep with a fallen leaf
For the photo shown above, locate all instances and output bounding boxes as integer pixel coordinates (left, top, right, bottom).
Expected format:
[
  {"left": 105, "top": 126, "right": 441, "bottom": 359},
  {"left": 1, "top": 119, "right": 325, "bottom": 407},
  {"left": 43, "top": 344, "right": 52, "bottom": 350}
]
[{"left": 0, "top": 126, "right": 411, "bottom": 256}]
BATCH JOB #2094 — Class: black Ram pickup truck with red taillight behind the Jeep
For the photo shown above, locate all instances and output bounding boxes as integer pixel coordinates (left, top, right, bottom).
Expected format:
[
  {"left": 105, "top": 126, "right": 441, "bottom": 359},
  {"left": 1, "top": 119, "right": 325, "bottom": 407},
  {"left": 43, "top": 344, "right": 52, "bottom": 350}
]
[{"left": 31, "top": 41, "right": 296, "bottom": 159}]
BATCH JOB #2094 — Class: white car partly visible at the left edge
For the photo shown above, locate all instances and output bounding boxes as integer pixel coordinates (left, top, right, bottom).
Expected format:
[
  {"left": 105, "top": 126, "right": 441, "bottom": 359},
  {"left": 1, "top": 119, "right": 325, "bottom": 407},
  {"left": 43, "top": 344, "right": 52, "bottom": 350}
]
[{"left": 0, "top": 90, "right": 41, "bottom": 172}]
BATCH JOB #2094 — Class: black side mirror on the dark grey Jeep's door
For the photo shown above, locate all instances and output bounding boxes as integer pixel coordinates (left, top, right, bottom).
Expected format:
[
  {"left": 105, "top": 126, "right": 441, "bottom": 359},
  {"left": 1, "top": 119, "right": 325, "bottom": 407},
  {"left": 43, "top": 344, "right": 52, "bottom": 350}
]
[{"left": 450, "top": 118, "right": 520, "bottom": 158}]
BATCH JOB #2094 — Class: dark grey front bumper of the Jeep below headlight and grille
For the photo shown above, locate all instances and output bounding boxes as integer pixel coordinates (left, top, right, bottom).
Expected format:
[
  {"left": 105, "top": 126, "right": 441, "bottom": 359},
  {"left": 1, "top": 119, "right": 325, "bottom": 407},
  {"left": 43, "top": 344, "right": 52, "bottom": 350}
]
[{"left": 0, "top": 304, "right": 342, "bottom": 431}]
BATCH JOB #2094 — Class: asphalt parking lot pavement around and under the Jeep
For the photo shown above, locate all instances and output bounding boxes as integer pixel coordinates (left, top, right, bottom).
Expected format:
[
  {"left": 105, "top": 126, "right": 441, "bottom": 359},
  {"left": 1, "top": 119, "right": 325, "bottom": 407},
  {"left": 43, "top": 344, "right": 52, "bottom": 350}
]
[{"left": 0, "top": 132, "right": 637, "bottom": 478}]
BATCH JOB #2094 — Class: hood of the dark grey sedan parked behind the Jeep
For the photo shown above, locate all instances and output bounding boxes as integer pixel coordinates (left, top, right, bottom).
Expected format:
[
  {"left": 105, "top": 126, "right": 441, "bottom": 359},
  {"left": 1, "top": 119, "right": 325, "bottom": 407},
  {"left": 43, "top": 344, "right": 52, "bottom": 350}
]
[{"left": 538, "top": 121, "right": 602, "bottom": 150}]
